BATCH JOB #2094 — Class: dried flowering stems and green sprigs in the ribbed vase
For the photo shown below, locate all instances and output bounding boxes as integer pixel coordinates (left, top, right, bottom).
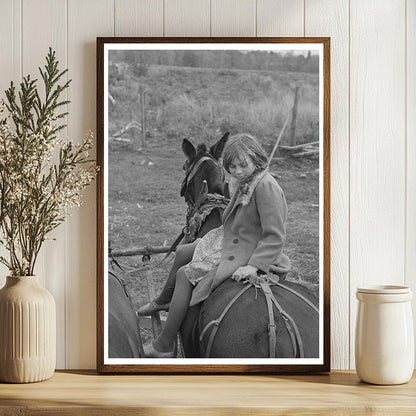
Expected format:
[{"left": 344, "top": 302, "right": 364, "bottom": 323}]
[{"left": 0, "top": 49, "right": 97, "bottom": 276}]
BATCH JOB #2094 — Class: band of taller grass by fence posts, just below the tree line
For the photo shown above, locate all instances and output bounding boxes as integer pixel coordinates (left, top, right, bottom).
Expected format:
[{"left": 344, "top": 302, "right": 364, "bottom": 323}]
[{"left": 109, "top": 65, "right": 318, "bottom": 144}]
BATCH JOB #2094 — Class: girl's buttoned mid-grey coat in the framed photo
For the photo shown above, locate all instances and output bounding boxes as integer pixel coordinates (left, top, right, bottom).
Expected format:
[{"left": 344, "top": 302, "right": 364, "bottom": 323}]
[{"left": 191, "top": 172, "right": 290, "bottom": 305}]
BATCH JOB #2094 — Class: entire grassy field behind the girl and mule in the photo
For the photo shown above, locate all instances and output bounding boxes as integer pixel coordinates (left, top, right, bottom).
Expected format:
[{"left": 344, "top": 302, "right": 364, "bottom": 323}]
[{"left": 109, "top": 61, "right": 319, "bottom": 320}]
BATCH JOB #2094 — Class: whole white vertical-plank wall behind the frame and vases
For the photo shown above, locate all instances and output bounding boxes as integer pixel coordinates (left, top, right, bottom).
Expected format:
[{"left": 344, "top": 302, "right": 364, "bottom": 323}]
[{"left": 0, "top": 0, "right": 416, "bottom": 369}]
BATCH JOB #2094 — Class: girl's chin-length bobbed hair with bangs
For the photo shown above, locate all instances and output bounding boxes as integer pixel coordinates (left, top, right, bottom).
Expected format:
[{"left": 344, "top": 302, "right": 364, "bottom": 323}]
[{"left": 223, "top": 133, "right": 267, "bottom": 173}]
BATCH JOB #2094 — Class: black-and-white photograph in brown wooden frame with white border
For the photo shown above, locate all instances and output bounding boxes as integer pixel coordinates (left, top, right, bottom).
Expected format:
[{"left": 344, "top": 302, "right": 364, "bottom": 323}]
[{"left": 97, "top": 38, "right": 330, "bottom": 373}]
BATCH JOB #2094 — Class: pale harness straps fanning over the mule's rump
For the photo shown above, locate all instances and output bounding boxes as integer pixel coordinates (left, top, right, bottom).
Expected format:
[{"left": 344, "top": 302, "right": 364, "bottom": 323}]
[{"left": 199, "top": 278, "right": 319, "bottom": 358}]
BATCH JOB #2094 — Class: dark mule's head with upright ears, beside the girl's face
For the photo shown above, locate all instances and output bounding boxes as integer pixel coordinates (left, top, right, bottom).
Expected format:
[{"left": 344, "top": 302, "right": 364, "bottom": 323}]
[{"left": 181, "top": 133, "right": 229, "bottom": 203}]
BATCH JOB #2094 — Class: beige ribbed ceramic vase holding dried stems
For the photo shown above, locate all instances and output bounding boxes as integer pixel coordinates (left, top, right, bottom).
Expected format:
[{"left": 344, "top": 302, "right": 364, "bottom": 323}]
[{"left": 0, "top": 276, "right": 56, "bottom": 383}]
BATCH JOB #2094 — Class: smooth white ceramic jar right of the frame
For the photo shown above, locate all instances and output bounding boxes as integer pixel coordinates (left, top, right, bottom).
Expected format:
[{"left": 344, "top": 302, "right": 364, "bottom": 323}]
[{"left": 355, "top": 286, "right": 415, "bottom": 384}]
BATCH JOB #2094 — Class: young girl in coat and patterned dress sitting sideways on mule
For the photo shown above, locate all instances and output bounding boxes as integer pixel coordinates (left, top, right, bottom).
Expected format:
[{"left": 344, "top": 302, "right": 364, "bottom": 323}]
[{"left": 145, "top": 134, "right": 290, "bottom": 358}]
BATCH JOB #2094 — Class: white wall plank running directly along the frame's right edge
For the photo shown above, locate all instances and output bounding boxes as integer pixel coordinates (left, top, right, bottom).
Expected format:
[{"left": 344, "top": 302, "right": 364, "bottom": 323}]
[{"left": 305, "top": 0, "right": 351, "bottom": 368}]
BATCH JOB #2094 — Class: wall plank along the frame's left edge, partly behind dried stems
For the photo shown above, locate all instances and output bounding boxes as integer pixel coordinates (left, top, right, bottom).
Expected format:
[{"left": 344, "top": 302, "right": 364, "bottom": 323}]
[{"left": 66, "top": 0, "right": 114, "bottom": 368}]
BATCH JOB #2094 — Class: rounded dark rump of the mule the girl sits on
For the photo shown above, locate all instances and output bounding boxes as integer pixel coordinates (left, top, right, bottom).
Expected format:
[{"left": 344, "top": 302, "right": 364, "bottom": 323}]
[{"left": 181, "top": 279, "right": 319, "bottom": 358}]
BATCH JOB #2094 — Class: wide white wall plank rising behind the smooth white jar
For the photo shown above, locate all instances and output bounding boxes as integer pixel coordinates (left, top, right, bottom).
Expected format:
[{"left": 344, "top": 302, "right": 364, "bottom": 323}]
[{"left": 349, "top": 0, "right": 404, "bottom": 368}]
